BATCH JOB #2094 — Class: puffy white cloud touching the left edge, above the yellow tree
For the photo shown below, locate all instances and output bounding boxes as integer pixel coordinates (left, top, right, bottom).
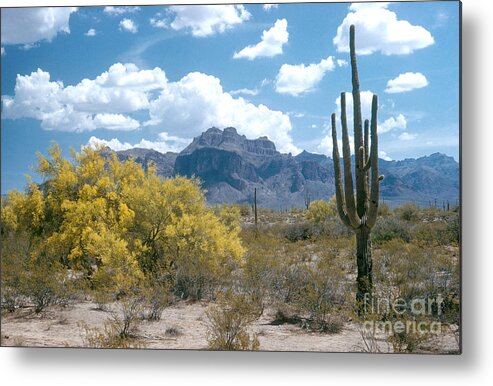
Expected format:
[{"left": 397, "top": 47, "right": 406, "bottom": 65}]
[{"left": 2, "top": 63, "right": 167, "bottom": 132}]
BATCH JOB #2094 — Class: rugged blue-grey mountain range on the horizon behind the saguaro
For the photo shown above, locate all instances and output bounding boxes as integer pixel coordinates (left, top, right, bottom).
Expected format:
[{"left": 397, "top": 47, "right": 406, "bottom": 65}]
[{"left": 111, "top": 127, "right": 460, "bottom": 209}]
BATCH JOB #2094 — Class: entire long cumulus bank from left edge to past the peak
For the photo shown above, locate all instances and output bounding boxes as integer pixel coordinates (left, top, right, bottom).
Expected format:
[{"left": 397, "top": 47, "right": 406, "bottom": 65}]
[{"left": 2, "top": 63, "right": 299, "bottom": 153}]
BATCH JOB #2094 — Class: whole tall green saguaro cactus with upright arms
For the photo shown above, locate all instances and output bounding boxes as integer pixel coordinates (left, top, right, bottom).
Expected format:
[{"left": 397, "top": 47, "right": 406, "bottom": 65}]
[{"left": 331, "top": 25, "right": 383, "bottom": 313}]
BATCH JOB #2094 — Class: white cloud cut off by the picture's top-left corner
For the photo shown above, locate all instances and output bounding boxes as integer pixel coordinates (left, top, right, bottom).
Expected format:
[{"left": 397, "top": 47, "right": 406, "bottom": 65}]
[{"left": 1, "top": 7, "right": 77, "bottom": 45}]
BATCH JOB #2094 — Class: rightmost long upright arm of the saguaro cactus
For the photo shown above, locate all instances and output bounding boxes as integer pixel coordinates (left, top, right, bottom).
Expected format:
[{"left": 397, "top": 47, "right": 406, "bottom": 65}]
[{"left": 367, "top": 95, "right": 381, "bottom": 229}]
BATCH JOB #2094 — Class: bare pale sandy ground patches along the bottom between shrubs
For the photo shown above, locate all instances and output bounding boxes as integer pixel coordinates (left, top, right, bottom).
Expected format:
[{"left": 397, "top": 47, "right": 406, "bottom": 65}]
[{"left": 1, "top": 302, "right": 458, "bottom": 353}]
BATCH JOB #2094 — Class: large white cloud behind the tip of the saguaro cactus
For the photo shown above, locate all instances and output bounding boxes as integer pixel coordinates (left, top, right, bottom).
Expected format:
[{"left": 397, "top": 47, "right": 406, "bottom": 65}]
[{"left": 333, "top": 3, "right": 434, "bottom": 55}]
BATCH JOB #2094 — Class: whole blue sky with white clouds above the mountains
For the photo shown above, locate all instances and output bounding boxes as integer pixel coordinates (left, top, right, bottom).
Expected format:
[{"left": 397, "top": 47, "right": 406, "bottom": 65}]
[{"left": 1, "top": 1, "right": 459, "bottom": 193}]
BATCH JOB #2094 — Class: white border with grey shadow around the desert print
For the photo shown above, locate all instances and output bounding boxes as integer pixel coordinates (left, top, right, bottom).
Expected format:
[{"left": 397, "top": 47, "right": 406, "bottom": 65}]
[{"left": 0, "top": 0, "right": 493, "bottom": 386}]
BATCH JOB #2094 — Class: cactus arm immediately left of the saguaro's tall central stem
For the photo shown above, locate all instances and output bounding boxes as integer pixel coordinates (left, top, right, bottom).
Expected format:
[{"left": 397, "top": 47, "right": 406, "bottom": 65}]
[{"left": 341, "top": 92, "right": 361, "bottom": 228}]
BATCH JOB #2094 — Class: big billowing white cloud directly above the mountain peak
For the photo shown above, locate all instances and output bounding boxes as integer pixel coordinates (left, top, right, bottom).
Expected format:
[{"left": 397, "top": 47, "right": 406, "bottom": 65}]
[{"left": 149, "top": 72, "right": 299, "bottom": 153}]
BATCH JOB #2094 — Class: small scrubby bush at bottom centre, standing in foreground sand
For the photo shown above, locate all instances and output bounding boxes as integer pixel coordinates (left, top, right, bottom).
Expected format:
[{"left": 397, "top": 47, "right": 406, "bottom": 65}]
[{"left": 206, "top": 292, "right": 260, "bottom": 350}]
